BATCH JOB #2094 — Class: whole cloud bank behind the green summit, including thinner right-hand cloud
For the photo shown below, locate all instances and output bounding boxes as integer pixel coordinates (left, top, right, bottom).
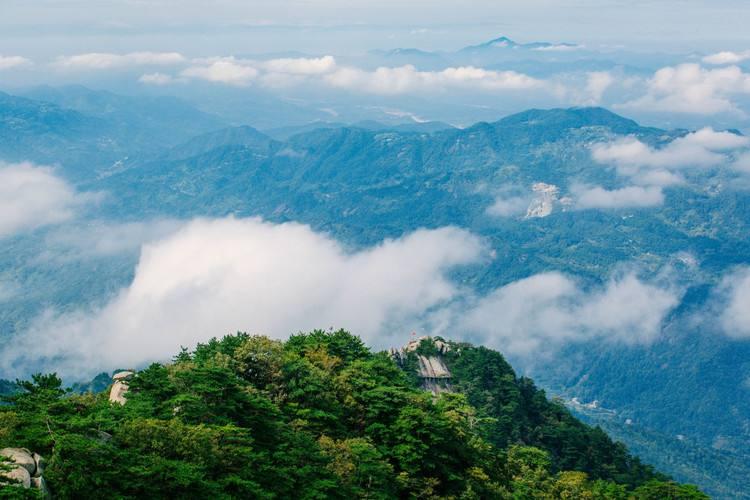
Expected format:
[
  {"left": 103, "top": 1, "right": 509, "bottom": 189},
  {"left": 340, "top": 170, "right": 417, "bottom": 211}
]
[{"left": 0, "top": 218, "right": 679, "bottom": 378}]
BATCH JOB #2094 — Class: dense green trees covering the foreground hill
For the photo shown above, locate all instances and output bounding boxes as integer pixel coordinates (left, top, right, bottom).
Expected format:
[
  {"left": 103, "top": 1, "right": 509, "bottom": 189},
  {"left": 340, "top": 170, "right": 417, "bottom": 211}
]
[{"left": 0, "top": 331, "right": 706, "bottom": 499}]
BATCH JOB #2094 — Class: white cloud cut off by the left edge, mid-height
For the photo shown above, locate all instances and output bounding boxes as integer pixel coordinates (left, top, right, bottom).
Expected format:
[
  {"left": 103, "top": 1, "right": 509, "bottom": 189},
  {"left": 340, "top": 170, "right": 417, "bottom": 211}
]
[{"left": 0, "top": 163, "right": 93, "bottom": 238}]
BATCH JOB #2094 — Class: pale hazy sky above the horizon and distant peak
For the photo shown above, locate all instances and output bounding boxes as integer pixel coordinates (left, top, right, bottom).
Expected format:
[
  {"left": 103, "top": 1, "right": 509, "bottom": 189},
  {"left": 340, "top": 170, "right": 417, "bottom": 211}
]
[{"left": 0, "top": 0, "right": 750, "bottom": 57}]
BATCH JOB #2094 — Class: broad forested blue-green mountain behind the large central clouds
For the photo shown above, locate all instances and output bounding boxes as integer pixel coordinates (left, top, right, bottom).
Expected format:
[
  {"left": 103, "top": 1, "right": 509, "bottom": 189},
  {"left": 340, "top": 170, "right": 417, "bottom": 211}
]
[{"left": 79, "top": 108, "right": 750, "bottom": 496}]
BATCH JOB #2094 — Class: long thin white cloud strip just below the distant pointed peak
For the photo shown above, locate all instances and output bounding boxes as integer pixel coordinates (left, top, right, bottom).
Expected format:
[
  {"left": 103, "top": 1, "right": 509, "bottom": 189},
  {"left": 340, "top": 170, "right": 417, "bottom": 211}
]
[{"left": 324, "top": 65, "right": 544, "bottom": 95}]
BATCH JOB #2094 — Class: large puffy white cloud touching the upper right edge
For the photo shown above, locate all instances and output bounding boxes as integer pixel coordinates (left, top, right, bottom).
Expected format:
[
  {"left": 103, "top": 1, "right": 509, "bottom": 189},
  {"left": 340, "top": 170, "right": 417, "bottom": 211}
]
[{"left": 619, "top": 63, "right": 750, "bottom": 115}]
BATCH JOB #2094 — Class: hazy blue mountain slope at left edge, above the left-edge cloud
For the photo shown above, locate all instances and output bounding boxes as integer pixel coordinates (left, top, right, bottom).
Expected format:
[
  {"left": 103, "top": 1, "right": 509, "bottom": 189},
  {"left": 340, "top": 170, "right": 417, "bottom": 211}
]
[{"left": 0, "top": 86, "right": 224, "bottom": 181}]
